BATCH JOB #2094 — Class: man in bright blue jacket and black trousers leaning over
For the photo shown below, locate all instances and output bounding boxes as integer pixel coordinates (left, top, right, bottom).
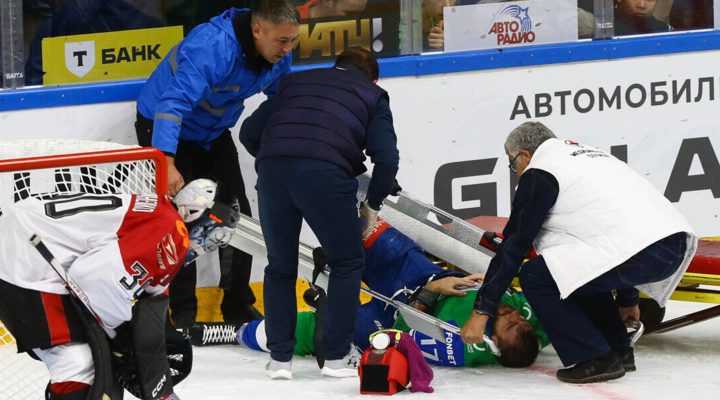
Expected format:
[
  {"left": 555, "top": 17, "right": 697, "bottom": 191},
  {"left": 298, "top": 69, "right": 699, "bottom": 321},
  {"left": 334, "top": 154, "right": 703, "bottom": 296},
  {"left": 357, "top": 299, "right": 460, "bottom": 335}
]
[{"left": 135, "top": 0, "right": 299, "bottom": 327}]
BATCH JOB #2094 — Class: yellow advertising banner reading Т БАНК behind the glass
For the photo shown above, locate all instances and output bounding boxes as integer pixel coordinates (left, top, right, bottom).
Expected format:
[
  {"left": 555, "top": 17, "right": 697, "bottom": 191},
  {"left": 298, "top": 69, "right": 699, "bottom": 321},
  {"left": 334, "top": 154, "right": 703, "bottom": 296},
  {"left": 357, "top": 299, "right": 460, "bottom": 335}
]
[{"left": 42, "top": 26, "right": 183, "bottom": 85}]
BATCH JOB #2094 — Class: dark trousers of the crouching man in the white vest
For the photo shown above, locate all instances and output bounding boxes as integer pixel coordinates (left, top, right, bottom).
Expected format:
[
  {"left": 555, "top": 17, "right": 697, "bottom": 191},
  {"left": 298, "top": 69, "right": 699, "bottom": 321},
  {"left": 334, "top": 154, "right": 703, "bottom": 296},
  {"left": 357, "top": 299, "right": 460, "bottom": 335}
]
[{"left": 520, "top": 232, "right": 687, "bottom": 366}]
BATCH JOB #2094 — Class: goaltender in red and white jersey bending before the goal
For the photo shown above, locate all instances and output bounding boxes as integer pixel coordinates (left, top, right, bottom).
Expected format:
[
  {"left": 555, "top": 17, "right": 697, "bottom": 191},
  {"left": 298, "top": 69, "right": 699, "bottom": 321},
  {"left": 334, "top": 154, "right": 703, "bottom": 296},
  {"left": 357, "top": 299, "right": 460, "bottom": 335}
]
[{"left": 0, "top": 179, "right": 238, "bottom": 400}]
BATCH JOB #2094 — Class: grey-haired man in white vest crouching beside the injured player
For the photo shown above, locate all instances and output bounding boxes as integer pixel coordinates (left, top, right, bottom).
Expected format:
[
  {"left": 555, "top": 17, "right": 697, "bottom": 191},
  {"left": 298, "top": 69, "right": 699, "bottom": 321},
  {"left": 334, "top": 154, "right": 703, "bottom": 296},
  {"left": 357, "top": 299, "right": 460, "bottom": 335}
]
[{"left": 461, "top": 122, "right": 697, "bottom": 383}]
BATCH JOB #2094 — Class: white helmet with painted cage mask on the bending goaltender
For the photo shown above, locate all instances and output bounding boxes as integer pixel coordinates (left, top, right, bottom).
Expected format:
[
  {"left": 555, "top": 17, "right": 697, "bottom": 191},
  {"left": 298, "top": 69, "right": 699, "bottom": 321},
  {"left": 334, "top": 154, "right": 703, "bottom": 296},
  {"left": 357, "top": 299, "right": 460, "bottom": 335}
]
[{"left": 173, "top": 179, "right": 240, "bottom": 264}]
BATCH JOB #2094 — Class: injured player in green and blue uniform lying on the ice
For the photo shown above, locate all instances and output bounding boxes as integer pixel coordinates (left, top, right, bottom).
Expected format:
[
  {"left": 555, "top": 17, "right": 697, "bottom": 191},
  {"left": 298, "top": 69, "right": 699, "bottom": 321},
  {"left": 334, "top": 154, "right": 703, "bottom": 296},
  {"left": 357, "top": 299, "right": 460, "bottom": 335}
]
[{"left": 236, "top": 219, "right": 549, "bottom": 367}]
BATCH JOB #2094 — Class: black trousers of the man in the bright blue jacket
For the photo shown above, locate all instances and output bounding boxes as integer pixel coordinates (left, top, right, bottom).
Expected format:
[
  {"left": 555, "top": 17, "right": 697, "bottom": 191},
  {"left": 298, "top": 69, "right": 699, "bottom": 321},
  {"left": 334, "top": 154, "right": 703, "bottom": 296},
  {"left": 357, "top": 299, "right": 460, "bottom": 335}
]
[{"left": 135, "top": 113, "right": 255, "bottom": 327}]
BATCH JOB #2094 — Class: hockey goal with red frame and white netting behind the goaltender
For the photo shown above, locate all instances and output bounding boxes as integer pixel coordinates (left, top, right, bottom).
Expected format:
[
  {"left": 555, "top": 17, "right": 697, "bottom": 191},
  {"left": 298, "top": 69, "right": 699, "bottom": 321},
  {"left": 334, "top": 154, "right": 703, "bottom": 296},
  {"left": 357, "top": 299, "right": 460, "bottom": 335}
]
[{"left": 0, "top": 139, "right": 167, "bottom": 399}]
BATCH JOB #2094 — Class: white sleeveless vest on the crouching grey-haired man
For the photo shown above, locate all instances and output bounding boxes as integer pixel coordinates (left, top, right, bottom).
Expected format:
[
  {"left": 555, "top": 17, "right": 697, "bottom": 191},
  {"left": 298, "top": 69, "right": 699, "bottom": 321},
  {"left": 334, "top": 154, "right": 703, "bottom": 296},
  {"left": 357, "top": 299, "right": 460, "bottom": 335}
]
[{"left": 527, "top": 139, "right": 697, "bottom": 306}]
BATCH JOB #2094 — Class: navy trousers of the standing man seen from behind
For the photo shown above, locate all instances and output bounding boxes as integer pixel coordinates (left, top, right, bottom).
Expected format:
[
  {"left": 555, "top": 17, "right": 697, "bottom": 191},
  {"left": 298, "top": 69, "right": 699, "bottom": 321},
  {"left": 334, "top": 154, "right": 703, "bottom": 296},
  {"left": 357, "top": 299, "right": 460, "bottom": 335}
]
[{"left": 257, "top": 157, "right": 365, "bottom": 362}]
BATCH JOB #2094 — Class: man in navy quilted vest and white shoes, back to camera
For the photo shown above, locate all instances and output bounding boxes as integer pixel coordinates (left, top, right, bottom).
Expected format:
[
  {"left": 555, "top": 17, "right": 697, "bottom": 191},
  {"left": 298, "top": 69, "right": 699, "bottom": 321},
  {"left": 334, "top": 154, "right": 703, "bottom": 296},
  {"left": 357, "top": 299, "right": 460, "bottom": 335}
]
[{"left": 240, "top": 49, "right": 399, "bottom": 379}]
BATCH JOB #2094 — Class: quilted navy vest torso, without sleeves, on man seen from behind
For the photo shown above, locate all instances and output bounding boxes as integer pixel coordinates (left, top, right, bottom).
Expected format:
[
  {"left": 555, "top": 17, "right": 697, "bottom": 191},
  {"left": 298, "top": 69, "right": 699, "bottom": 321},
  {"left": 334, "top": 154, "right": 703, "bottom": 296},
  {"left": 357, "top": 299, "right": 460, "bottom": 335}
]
[{"left": 256, "top": 66, "right": 387, "bottom": 176}]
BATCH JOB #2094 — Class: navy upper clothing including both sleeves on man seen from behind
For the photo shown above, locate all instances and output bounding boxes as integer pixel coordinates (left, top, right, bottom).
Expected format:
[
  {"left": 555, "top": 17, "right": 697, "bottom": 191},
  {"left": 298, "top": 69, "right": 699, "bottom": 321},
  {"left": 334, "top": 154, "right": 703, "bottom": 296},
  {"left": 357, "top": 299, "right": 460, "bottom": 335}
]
[{"left": 240, "top": 65, "right": 399, "bottom": 209}]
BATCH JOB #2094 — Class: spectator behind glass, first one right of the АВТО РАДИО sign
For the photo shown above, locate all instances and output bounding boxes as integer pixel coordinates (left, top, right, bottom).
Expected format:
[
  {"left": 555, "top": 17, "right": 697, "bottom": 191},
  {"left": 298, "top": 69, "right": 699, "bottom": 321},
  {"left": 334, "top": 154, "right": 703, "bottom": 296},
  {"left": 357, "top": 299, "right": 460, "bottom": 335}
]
[{"left": 615, "top": 0, "right": 670, "bottom": 36}]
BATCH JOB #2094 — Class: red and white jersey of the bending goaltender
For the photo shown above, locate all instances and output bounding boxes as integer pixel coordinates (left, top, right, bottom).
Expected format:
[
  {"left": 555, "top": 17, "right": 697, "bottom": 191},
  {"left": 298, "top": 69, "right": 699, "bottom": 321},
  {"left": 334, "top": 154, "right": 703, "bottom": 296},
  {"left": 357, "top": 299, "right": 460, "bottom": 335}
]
[{"left": 0, "top": 193, "right": 190, "bottom": 329}]
